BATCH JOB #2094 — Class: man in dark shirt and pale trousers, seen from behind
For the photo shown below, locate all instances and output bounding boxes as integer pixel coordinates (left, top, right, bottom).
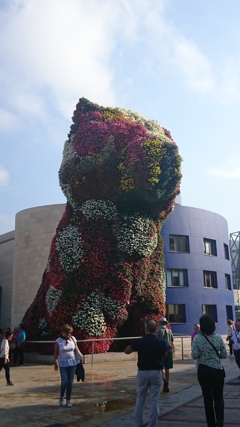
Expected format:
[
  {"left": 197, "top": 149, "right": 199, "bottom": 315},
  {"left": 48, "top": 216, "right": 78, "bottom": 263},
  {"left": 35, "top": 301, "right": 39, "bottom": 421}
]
[{"left": 124, "top": 319, "right": 167, "bottom": 427}]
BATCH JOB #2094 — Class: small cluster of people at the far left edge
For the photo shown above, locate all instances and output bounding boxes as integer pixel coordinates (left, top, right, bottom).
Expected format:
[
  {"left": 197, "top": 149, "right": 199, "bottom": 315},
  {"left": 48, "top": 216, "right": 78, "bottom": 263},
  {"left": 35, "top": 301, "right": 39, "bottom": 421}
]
[{"left": 0, "top": 325, "right": 26, "bottom": 386}]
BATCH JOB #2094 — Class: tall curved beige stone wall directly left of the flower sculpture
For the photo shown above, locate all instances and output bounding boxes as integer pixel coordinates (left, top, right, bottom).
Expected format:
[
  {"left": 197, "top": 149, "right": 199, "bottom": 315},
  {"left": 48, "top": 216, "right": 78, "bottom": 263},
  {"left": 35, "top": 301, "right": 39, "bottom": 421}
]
[{"left": 11, "top": 204, "right": 65, "bottom": 327}]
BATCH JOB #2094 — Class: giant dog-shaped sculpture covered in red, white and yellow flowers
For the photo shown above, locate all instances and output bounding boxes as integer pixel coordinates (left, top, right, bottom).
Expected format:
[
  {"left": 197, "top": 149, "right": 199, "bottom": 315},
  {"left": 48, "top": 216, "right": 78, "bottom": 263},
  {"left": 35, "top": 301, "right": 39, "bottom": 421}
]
[{"left": 23, "top": 98, "right": 181, "bottom": 352}]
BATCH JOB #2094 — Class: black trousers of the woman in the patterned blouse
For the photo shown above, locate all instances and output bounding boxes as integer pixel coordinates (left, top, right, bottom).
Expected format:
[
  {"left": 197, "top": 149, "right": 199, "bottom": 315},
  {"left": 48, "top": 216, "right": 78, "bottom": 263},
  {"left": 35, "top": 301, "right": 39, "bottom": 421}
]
[{"left": 198, "top": 364, "right": 224, "bottom": 427}]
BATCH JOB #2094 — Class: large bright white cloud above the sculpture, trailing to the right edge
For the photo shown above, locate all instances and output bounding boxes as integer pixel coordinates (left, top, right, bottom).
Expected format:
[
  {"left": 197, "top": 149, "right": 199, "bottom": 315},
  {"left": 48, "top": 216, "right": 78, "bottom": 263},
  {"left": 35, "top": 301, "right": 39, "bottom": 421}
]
[{"left": 0, "top": 0, "right": 240, "bottom": 130}]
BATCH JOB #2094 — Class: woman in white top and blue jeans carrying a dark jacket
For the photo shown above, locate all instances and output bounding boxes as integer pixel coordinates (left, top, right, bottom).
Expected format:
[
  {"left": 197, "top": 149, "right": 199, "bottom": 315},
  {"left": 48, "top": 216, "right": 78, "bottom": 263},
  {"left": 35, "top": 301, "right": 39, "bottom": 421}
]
[{"left": 54, "top": 325, "right": 83, "bottom": 408}]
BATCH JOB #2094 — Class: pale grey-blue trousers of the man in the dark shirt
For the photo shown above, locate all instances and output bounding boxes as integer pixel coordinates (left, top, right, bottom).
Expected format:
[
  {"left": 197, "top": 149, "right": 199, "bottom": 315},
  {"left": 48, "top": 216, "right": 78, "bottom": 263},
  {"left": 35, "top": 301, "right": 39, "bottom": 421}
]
[{"left": 135, "top": 371, "right": 162, "bottom": 427}]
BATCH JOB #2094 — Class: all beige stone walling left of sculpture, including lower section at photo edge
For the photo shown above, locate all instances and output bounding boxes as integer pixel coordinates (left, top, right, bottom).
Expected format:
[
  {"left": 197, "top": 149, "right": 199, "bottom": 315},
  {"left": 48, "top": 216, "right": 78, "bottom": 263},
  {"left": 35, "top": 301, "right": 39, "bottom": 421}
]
[{"left": 0, "top": 204, "right": 65, "bottom": 328}]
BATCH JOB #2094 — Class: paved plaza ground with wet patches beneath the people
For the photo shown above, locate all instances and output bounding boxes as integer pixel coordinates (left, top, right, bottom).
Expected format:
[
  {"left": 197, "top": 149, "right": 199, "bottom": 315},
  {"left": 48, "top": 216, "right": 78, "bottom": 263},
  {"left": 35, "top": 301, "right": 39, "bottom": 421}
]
[{"left": 0, "top": 356, "right": 240, "bottom": 427}]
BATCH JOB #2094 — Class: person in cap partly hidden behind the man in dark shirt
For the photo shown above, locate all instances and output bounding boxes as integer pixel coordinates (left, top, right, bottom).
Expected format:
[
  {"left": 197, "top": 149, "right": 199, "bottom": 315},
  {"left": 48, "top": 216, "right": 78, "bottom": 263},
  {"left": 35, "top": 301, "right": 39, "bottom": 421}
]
[{"left": 156, "top": 317, "right": 175, "bottom": 393}]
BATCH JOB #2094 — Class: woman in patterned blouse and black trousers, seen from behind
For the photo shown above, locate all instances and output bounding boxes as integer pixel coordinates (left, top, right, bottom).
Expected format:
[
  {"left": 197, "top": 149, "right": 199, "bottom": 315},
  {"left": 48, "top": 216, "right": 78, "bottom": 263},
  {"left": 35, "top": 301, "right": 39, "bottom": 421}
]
[{"left": 192, "top": 314, "right": 227, "bottom": 427}]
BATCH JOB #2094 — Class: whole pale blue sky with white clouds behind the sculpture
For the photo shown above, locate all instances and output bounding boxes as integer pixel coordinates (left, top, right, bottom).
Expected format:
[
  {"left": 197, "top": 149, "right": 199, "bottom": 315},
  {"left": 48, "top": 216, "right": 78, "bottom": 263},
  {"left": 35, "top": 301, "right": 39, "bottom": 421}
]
[{"left": 0, "top": 0, "right": 240, "bottom": 234}]
